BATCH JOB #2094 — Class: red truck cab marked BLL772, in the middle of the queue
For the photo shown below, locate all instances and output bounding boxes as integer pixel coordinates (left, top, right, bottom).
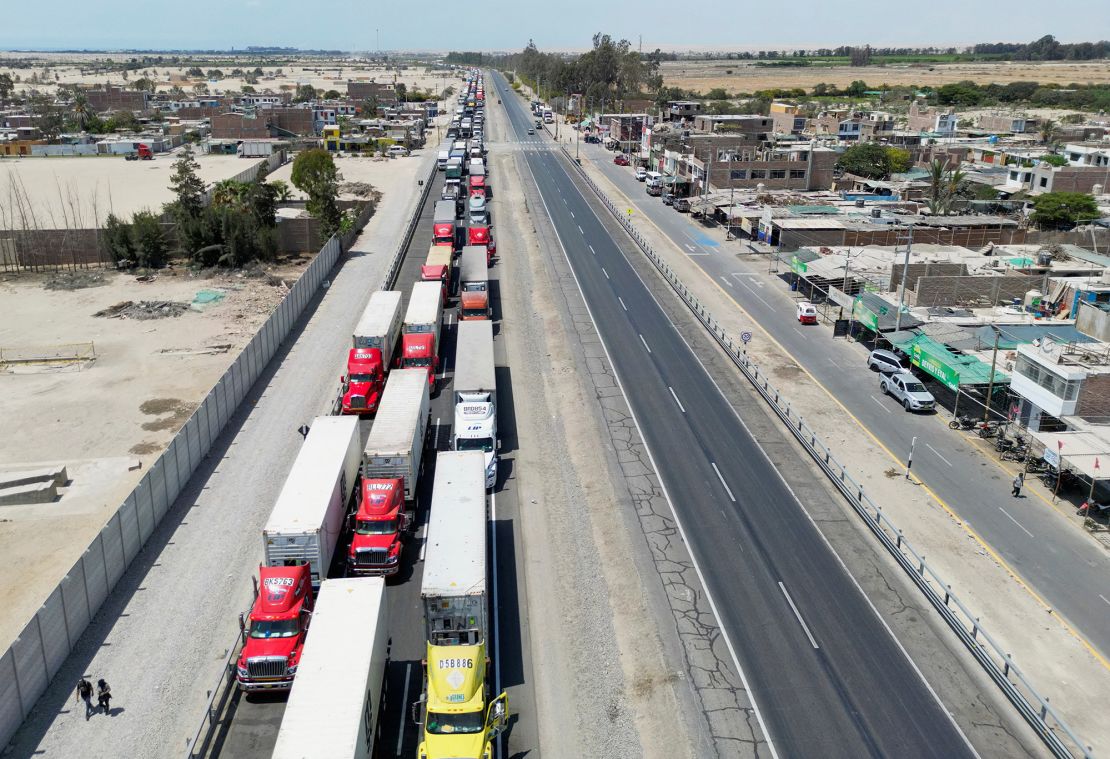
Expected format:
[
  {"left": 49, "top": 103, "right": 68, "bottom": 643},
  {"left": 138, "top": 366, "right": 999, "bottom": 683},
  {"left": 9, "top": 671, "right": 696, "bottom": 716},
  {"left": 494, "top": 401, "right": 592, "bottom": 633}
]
[{"left": 347, "top": 478, "right": 412, "bottom": 577}]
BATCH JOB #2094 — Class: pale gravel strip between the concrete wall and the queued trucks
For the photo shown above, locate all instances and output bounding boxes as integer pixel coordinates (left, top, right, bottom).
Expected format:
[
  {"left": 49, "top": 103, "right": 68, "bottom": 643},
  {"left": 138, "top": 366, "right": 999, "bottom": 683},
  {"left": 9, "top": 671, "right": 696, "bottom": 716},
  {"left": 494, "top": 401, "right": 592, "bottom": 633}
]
[{"left": 12, "top": 148, "right": 435, "bottom": 757}]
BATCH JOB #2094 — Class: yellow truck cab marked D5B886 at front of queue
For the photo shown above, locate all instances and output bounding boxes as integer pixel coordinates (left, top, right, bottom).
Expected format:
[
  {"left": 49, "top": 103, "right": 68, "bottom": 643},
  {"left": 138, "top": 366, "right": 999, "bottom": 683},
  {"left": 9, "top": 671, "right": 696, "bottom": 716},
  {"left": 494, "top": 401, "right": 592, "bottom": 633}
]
[{"left": 416, "top": 644, "right": 508, "bottom": 759}]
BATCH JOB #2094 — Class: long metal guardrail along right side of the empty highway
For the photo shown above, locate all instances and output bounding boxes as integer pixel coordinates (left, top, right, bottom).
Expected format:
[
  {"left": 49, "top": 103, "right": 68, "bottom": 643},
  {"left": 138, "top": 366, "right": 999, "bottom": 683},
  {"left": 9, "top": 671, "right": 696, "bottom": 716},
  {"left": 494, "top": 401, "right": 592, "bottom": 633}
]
[{"left": 561, "top": 146, "right": 1093, "bottom": 759}]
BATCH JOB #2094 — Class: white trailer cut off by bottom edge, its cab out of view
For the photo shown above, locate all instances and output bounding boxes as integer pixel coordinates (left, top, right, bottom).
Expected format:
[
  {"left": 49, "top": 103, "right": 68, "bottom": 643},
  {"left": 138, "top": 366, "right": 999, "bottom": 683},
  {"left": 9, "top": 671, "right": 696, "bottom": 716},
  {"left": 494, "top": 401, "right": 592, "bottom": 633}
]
[{"left": 273, "top": 577, "right": 390, "bottom": 759}]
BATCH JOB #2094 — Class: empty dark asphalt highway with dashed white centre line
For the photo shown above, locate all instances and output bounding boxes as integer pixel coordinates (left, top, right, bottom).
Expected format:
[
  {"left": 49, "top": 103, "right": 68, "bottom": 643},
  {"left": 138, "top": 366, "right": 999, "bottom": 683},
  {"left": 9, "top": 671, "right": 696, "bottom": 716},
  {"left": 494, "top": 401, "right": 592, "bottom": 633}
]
[{"left": 493, "top": 68, "right": 975, "bottom": 757}]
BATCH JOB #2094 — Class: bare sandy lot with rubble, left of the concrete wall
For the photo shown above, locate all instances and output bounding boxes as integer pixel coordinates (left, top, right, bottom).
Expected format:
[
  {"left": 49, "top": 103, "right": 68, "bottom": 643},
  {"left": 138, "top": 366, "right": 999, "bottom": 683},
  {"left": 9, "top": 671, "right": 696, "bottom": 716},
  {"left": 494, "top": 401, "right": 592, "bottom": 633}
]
[{"left": 0, "top": 262, "right": 306, "bottom": 641}]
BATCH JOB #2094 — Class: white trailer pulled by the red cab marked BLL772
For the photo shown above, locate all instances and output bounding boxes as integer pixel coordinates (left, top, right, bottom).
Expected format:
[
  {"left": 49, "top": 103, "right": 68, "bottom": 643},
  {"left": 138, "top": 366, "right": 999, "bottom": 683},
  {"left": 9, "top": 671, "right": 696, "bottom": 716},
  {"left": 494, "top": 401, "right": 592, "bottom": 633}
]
[{"left": 362, "top": 368, "right": 430, "bottom": 500}]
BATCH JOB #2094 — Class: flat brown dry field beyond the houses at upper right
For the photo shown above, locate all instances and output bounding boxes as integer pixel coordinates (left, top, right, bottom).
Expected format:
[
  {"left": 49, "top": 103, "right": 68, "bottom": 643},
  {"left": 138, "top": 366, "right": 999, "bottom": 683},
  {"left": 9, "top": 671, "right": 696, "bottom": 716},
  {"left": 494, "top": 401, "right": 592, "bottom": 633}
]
[{"left": 662, "top": 61, "right": 1110, "bottom": 93}]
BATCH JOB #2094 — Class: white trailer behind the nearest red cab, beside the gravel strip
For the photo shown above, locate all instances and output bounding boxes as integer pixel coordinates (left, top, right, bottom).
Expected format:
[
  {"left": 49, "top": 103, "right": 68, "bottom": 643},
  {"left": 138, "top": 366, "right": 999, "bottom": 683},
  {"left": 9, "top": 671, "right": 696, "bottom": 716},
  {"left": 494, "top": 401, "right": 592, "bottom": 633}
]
[{"left": 262, "top": 416, "right": 359, "bottom": 586}]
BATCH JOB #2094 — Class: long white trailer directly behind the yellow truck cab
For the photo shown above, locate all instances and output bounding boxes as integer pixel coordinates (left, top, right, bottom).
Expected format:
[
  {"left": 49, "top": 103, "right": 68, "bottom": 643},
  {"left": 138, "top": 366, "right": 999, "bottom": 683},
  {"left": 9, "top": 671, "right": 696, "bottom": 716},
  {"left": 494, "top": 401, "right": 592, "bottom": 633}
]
[{"left": 421, "top": 451, "right": 487, "bottom": 646}]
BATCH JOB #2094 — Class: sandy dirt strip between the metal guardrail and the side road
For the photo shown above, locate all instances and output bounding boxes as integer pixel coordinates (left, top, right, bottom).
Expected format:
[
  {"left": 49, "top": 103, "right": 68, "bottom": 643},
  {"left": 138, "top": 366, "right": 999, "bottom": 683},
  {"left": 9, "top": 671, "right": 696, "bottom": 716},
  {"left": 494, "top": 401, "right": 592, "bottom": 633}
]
[{"left": 583, "top": 148, "right": 1110, "bottom": 748}]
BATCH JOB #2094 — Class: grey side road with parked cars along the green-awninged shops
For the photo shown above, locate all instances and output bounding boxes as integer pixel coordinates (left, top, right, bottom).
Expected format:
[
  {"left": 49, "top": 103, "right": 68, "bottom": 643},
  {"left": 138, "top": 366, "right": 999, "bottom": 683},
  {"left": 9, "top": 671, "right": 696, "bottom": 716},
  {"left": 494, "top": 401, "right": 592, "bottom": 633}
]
[{"left": 572, "top": 137, "right": 1110, "bottom": 666}]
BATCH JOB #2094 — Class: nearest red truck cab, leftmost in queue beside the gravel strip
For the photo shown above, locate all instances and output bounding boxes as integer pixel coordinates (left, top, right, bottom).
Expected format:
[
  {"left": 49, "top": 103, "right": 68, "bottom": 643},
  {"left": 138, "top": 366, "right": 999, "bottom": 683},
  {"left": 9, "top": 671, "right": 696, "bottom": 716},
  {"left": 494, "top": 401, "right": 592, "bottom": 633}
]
[{"left": 235, "top": 564, "right": 313, "bottom": 691}]
